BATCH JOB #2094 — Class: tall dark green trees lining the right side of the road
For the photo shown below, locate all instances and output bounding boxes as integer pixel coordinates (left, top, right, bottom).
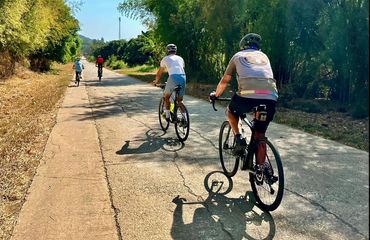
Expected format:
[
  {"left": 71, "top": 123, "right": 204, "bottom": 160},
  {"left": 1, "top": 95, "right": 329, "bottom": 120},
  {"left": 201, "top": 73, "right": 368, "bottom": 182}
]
[{"left": 119, "top": 0, "right": 369, "bottom": 115}]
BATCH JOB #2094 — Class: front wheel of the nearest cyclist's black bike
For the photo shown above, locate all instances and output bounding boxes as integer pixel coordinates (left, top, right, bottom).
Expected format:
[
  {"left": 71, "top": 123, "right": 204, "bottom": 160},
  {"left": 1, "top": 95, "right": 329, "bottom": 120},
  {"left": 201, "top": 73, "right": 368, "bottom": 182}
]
[{"left": 218, "top": 121, "right": 239, "bottom": 177}]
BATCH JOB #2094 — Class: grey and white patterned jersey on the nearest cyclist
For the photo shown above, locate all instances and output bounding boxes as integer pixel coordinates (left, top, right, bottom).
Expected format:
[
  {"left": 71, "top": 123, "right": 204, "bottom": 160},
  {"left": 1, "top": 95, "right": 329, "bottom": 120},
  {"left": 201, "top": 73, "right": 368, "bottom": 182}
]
[{"left": 225, "top": 49, "right": 278, "bottom": 101}]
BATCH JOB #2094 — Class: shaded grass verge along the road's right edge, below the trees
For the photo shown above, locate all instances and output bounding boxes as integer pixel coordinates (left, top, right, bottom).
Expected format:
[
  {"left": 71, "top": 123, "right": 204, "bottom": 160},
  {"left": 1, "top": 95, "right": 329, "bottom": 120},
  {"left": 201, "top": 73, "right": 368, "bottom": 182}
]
[{"left": 119, "top": 69, "right": 369, "bottom": 152}]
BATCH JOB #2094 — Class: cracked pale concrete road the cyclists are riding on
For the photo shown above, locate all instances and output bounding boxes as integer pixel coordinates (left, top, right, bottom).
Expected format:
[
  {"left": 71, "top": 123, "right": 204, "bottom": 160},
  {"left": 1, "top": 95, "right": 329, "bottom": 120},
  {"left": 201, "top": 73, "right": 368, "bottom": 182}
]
[{"left": 10, "top": 63, "right": 369, "bottom": 240}]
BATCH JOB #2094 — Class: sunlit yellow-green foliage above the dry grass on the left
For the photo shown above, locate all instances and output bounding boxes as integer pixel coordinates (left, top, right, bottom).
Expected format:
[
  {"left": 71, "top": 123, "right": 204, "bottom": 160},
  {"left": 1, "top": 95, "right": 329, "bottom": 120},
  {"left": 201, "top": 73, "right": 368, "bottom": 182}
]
[{"left": 0, "top": 0, "right": 80, "bottom": 77}]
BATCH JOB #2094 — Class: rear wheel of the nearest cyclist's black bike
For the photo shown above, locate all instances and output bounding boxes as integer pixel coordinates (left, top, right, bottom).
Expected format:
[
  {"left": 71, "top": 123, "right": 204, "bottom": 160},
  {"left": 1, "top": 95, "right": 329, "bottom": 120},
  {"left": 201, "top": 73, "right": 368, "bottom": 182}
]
[{"left": 249, "top": 139, "right": 284, "bottom": 211}]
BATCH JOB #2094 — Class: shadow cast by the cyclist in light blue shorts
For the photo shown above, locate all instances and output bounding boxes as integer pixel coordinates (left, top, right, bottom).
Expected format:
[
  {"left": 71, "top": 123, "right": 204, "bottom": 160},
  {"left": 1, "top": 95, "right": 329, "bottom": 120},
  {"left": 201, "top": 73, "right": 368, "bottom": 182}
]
[{"left": 116, "top": 129, "right": 184, "bottom": 155}]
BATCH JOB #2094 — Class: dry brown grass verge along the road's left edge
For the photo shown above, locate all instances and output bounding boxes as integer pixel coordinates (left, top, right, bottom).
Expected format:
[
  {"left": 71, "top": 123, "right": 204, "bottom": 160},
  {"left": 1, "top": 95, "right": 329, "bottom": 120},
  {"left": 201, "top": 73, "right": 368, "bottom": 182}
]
[{"left": 0, "top": 65, "right": 72, "bottom": 239}]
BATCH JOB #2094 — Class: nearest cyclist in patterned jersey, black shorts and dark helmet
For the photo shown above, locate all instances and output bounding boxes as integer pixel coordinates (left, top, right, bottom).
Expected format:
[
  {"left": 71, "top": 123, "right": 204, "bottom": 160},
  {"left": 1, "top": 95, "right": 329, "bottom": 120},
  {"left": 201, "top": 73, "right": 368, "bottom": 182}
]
[{"left": 209, "top": 33, "right": 278, "bottom": 174}]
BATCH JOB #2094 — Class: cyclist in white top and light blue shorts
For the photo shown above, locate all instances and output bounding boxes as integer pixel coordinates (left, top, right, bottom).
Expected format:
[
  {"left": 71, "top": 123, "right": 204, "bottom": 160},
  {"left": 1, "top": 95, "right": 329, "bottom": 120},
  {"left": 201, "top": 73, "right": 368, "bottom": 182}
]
[{"left": 153, "top": 43, "right": 187, "bottom": 124}]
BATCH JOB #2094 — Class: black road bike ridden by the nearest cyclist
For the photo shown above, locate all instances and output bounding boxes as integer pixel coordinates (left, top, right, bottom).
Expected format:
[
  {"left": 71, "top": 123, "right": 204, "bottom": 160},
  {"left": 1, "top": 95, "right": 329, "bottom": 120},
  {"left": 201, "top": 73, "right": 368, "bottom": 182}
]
[{"left": 211, "top": 98, "right": 284, "bottom": 211}]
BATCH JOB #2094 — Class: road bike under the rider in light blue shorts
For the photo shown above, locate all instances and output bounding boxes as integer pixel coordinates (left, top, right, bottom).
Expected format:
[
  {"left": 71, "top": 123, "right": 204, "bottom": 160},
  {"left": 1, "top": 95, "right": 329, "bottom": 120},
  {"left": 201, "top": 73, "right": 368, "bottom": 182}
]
[{"left": 155, "top": 84, "right": 190, "bottom": 142}]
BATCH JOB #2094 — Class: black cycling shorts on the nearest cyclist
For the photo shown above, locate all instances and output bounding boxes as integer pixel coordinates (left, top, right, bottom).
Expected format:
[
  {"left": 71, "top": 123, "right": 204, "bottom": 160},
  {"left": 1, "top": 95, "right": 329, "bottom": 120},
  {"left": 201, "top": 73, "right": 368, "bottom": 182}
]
[{"left": 229, "top": 94, "right": 276, "bottom": 133}]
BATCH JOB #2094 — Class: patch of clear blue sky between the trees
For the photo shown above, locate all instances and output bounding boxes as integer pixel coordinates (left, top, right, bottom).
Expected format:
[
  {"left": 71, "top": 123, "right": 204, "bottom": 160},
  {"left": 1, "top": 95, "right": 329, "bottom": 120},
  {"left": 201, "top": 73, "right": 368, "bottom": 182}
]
[{"left": 76, "top": 0, "right": 146, "bottom": 41}]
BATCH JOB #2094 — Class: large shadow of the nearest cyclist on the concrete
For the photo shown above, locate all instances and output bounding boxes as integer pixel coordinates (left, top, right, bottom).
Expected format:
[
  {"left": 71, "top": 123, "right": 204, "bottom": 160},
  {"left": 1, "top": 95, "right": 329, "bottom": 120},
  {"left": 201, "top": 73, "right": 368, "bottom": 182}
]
[{"left": 171, "top": 171, "right": 276, "bottom": 240}]
